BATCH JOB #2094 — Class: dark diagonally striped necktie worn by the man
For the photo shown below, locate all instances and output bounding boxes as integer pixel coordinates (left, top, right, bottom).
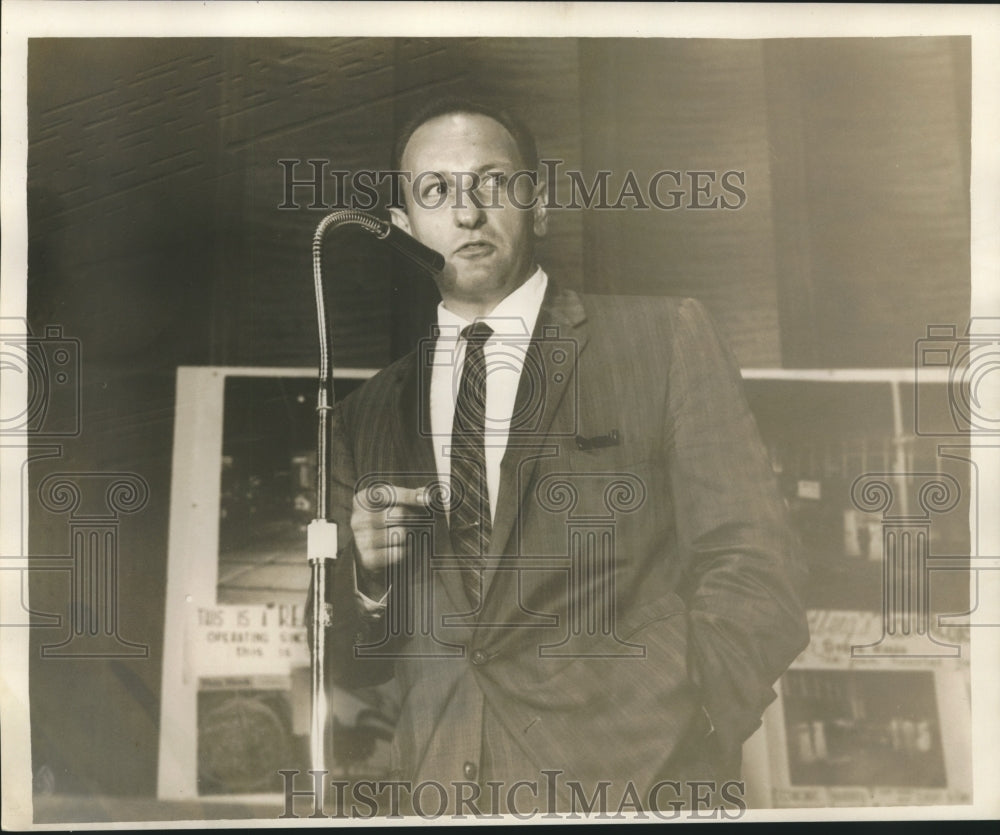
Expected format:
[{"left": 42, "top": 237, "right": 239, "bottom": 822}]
[{"left": 449, "top": 322, "right": 493, "bottom": 608}]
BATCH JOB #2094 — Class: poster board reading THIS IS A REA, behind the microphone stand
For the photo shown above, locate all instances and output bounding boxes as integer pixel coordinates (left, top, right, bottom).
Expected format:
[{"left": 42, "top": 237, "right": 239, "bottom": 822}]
[{"left": 157, "top": 367, "right": 387, "bottom": 802}]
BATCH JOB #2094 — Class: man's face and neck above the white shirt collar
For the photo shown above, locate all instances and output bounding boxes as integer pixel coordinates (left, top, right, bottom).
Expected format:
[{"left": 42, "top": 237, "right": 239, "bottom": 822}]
[{"left": 391, "top": 113, "right": 545, "bottom": 315}]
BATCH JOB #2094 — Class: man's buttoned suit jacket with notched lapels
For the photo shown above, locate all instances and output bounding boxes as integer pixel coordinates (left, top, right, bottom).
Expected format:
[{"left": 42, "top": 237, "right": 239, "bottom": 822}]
[{"left": 329, "top": 284, "right": 808, "bottom": 804}]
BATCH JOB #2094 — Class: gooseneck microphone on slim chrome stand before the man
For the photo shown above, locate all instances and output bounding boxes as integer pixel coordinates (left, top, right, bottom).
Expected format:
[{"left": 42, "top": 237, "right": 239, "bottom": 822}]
[{"left": 307, "top": 209, "right": 444, "bottom": 792}]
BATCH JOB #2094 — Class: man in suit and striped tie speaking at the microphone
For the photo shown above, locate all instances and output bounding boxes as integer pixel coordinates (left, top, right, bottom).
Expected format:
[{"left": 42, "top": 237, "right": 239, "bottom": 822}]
[{"left": 329, "top": 102, "right": 808, "bottom": 811}]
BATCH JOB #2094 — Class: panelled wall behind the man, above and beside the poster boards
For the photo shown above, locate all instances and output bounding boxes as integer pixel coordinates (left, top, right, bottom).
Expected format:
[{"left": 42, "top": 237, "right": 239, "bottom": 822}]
[{"left": 28, "top": 38, "right": 970, "bottom": 795}]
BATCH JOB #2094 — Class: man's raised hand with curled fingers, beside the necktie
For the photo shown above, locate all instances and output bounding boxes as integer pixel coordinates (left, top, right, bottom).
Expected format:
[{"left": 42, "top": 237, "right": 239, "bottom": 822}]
[{"left": 351, "top": 484, "right": 429, "bottom": 600}]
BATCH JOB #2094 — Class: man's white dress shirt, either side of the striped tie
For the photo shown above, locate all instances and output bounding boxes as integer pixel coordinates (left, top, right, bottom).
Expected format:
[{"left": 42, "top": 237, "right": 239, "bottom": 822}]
[{"left": 430, "top": 267, "right": 549, "bottom": 518}]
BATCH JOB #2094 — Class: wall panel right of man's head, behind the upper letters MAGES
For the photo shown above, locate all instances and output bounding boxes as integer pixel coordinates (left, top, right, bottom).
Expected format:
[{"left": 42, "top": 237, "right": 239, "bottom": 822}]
[{"left": 580, "top": 38, "right": 780, "bottom": 365}]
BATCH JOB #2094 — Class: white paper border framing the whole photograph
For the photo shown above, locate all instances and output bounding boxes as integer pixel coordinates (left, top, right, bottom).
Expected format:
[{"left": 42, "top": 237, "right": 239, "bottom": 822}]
[{"left": 0, "top": 0, "right": 1000, "bottom": 829}]
